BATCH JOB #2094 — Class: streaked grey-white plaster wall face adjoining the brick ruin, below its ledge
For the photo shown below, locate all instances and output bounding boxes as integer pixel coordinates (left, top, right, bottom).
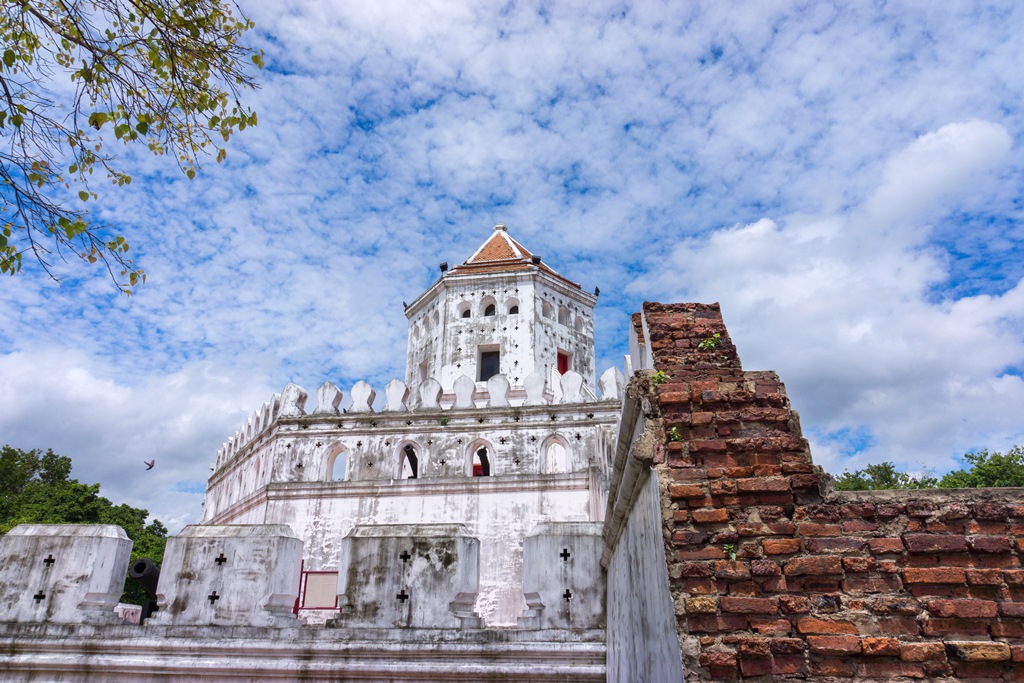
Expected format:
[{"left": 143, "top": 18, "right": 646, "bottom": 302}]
[{"left": 607, "top": 472, "right": 683, "bottom": 683}]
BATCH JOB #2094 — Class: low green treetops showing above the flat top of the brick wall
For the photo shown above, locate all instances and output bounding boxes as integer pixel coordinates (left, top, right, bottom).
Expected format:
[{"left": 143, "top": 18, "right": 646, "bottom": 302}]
[{"left": 833, "top": 445, "right": 1024, "bottom": 490}]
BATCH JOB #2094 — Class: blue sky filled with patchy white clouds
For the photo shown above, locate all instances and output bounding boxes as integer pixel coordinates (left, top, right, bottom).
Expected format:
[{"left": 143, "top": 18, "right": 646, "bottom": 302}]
[{"left": 0, "top": 0, "right": 1024, "bottom": 529}]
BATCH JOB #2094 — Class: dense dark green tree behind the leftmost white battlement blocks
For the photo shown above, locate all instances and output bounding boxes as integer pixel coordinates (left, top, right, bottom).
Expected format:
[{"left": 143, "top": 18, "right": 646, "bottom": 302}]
[{"left": 0, "top": 445, "right": 167, "bottom": 604}]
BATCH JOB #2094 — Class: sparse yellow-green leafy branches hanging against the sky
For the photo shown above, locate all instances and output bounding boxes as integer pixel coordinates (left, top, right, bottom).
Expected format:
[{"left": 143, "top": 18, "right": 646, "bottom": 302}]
[{"left": 0, "top": 0, "right": 263, "bottom": 294}]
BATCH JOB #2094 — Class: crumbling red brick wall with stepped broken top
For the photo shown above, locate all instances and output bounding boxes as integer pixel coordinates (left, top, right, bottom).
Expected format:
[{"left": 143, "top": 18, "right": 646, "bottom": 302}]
[{"left": 643, "top": 303, "right": 1024, "bottom": 681}]
